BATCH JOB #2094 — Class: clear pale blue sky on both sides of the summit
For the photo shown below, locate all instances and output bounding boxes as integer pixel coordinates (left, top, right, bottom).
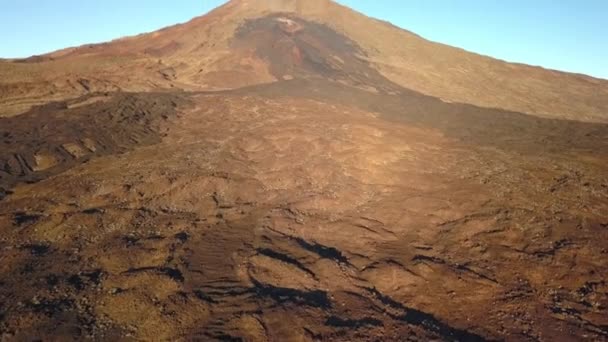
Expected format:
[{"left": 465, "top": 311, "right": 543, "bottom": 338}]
[{"left": 0, "top": 0, "right": 608, "bottom": 79}]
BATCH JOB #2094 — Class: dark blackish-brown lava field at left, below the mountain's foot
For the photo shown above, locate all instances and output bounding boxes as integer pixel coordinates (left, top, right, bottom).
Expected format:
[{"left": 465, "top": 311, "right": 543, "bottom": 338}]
[{"left": 0, "top": 93, "right": 189, "bottom": 195}]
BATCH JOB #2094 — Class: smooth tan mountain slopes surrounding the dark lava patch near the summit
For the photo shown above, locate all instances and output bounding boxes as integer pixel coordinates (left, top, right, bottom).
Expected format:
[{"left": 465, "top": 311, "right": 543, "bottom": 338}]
[{"left": 0, "top": 0, "right": 608, "bottom": 122}]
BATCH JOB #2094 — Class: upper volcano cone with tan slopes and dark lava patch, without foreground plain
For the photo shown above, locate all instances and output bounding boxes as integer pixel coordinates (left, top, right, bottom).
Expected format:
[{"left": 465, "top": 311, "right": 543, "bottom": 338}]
[{"left": 0, "top": 0, "right": 608, "bottom": 122}]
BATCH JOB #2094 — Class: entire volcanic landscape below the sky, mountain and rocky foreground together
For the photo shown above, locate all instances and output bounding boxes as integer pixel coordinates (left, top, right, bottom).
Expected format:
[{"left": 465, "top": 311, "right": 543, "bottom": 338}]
[{"left": 0, "top": 0, "right": 608, "bottom": 341}]
